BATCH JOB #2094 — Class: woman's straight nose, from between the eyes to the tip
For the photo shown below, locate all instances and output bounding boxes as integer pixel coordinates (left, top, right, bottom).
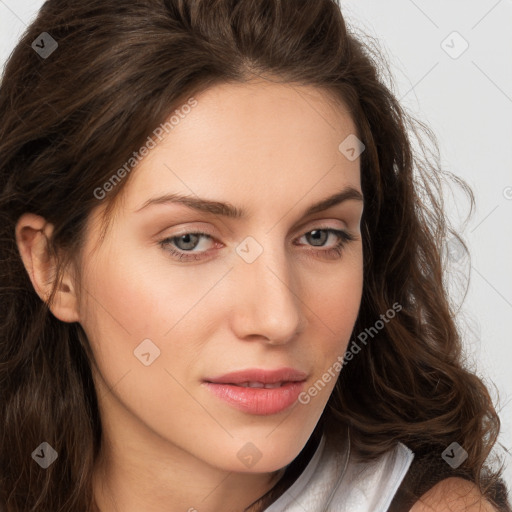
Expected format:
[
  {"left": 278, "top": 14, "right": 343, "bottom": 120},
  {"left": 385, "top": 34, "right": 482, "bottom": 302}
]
[{"left": 231, "top": 233, "right": 304, "bottom": 343}]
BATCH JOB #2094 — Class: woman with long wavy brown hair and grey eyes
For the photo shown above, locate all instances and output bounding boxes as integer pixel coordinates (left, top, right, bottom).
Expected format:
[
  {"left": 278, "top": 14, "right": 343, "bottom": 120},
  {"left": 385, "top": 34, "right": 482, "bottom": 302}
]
[{"left": 0, "top": 0, "right": 510, "bottom": 512}]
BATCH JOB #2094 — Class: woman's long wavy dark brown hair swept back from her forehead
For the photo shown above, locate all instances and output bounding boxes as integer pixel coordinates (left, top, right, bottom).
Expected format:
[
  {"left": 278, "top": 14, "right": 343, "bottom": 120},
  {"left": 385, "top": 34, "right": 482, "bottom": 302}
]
[{"left": 0, "top": 0, "right": 509, "bottom": 512}]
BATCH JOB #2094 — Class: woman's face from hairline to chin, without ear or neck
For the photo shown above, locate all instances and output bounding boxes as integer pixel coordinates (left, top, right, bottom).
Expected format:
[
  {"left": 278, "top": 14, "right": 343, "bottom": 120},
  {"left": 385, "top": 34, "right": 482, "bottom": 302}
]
[{"left": 79, "top": 78, "right": 363, "bottom": 472}]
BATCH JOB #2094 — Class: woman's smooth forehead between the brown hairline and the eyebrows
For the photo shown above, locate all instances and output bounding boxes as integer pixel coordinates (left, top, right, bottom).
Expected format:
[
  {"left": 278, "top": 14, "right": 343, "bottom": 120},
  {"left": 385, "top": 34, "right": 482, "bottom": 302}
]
[{"left": 125, "top": 81, "right": 359, "bottom": 192}]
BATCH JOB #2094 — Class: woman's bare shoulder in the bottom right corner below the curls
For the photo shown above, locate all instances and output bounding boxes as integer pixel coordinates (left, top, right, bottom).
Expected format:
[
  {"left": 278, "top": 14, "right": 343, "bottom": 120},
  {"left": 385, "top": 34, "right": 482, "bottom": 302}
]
[{"left": 410, "top": 477, "right": 498, "bottom": 512}]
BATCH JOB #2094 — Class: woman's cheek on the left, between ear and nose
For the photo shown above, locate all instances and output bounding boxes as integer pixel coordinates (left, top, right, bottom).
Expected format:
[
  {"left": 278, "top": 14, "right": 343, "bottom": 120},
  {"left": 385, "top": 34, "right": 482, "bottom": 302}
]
[{"left": 76, "top": 239, "right": 224, "bottom": 384}]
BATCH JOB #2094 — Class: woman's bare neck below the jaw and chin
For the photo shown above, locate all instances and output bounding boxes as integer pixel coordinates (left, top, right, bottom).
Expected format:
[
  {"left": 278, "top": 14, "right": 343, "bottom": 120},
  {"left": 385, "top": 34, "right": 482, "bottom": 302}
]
[{"left": 93, "top": 440, "right": 285, "bottom": 512}]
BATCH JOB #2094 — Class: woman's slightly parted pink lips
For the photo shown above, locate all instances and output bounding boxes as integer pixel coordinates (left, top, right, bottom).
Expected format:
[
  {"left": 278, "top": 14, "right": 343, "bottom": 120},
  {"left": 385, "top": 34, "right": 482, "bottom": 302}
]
[{"left": 203, "top": 368, "right": 307, "bottom": 415}]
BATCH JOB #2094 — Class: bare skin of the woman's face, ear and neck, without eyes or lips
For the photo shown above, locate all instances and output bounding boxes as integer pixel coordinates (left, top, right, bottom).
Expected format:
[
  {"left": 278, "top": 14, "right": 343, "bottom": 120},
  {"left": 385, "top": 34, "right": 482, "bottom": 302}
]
[{"left": 16, "top": 81, "right": 363, "bottom": 512}]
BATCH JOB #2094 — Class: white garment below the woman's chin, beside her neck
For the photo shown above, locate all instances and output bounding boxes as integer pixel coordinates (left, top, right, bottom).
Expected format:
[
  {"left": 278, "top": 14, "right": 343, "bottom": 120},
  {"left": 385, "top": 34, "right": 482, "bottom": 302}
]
[{"left": 264, "top": 437, "right": 414, "bottom": 512}]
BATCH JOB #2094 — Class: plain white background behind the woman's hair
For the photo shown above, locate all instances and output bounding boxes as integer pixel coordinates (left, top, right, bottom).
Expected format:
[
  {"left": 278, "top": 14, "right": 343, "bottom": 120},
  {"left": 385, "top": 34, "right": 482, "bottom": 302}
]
[{"left": 0, "top": 0, "right": 512, "bottom": 492}]
